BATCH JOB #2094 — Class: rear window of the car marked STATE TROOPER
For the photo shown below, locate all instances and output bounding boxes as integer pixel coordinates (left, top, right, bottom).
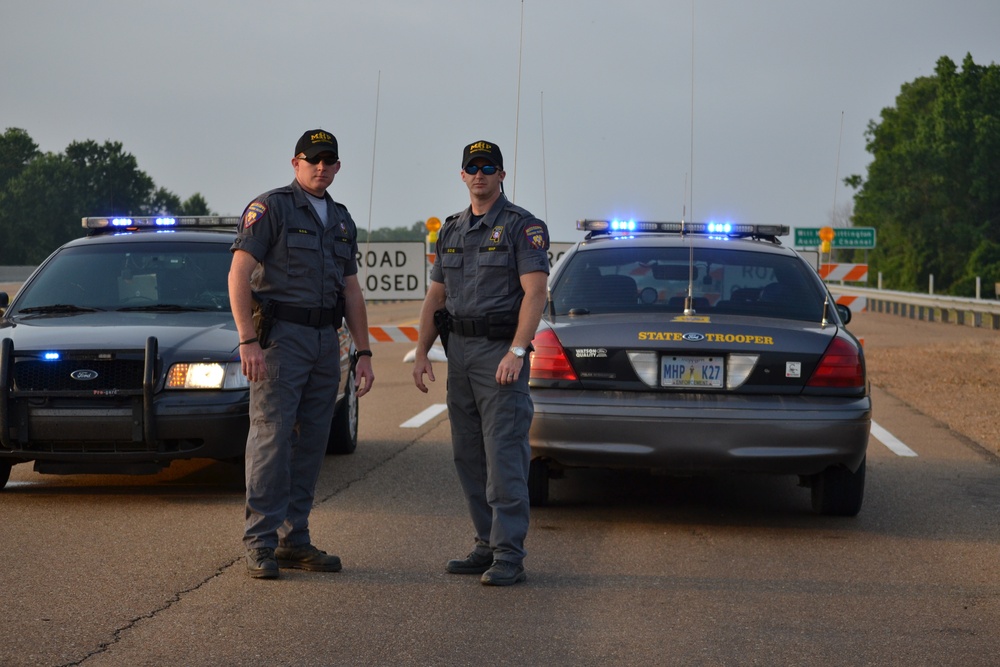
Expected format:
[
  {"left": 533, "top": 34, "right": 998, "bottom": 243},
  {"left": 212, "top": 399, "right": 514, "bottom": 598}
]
[{"left": 552, "top": 247, "right": 824, "bottom": 321}]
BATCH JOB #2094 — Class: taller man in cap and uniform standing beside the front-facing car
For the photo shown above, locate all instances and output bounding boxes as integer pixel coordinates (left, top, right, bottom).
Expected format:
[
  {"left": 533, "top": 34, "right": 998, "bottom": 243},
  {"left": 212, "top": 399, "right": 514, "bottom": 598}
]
[{"left": 229, "top": 129, "right": 375, "bottom": 579}]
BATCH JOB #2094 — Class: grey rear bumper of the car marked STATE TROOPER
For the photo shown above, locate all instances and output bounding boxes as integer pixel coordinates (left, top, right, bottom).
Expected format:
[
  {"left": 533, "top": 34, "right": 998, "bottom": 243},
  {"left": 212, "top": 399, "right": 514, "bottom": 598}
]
[{"left": 530, "top": 389, "right": 871, "bottom": 475}]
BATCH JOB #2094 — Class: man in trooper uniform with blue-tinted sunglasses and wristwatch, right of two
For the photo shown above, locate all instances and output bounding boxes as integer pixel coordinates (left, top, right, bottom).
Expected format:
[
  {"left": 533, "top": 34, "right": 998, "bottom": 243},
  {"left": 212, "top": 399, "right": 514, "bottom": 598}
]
[{"left": 413, "top": 141, "right": 549, "bottom": 586}]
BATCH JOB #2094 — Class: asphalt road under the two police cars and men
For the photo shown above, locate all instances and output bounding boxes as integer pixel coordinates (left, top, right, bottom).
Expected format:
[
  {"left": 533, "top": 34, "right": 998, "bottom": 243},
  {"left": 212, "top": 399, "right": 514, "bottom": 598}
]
[{"left": 0, "top": 304, "right": 1000, "bottom": 667}]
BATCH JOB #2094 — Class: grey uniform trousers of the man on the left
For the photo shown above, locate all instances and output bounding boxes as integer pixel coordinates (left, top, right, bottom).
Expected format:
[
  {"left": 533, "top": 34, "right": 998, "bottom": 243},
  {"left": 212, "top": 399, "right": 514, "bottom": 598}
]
[{"left": 243, "top": 320, "right": 340, "bottom": 549}]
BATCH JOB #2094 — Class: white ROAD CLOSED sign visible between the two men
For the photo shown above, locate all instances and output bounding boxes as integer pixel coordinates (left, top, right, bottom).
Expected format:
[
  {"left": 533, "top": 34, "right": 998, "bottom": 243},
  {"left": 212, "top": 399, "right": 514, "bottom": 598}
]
[{"left": 358, "top": 241, "right": 427, "bottom": 301}]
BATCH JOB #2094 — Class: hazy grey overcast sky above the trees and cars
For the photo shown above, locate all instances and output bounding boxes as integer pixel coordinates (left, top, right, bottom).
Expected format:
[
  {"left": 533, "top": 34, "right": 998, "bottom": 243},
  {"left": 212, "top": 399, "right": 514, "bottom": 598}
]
[{"left": 0, "top": 0, "right": 1000, "bottom": 241}]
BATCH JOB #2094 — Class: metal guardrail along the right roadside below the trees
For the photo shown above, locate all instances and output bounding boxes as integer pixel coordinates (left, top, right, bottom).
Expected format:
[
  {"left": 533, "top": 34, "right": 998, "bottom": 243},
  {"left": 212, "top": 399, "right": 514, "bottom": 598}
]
[{"left": 829, "top": 284, "right": 1000, "bottom": 329}]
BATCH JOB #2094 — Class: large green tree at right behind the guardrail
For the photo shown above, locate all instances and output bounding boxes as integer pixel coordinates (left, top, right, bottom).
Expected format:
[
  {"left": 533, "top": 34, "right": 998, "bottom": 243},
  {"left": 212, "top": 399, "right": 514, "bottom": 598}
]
[{"left": 845, "top": 55, "right": 1000, "bottom": 294}]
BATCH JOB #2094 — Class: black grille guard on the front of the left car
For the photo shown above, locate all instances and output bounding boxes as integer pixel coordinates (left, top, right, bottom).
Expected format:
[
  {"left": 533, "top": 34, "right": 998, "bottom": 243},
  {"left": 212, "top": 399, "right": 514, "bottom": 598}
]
[{"left": 0, "top": 336, "right": 159, "bottom": 450}]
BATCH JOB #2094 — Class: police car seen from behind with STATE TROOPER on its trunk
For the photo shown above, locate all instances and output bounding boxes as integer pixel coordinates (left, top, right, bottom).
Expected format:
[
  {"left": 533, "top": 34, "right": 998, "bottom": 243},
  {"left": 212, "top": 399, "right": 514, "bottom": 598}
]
[{"left": 529, "top": 220, "right": 872, "bottom": 515}]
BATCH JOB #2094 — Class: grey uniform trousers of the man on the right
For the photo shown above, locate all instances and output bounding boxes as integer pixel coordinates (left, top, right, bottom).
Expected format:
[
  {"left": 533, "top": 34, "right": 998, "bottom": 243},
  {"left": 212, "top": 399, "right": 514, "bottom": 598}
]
[{"left": 448, "top": 334, "right": 534, "bottom": 563}]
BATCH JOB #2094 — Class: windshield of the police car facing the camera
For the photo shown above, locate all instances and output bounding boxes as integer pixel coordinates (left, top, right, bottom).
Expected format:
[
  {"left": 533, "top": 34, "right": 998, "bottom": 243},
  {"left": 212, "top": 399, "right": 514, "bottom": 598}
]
[{"left": 15, "top": 242, "right": 231, "bottom": 311}]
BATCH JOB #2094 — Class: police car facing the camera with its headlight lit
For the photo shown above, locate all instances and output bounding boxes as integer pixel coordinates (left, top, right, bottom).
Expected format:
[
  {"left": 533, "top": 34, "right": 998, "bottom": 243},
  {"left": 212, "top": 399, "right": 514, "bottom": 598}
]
[{"left": 0, "top": 216, "right": 358, "bottom": 488}]
